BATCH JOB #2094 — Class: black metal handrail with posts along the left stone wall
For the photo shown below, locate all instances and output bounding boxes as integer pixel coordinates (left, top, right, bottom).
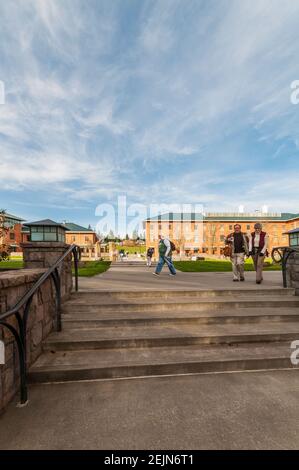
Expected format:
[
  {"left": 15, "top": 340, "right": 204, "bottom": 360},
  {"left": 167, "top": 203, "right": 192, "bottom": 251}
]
[{"left": 0, "top": 245, "right": 80, "bottom": 404}]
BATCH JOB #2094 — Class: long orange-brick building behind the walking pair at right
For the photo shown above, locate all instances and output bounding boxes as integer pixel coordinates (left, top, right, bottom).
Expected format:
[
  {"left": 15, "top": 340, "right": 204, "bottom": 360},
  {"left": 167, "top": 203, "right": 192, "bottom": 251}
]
[{"left": 145, "top": 213, "right": 299, "bottom": 256}]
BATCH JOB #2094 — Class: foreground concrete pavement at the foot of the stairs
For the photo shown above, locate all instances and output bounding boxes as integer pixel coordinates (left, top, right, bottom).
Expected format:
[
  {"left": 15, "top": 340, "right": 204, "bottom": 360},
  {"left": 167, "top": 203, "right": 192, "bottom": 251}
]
[{"left": 0, "top": 371, "right": 299, "bottom": 450}]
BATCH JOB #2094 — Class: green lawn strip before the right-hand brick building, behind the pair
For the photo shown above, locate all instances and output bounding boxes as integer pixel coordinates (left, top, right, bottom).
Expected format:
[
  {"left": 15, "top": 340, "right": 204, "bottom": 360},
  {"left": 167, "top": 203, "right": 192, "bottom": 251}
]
[{"left": 174, "top": 260, "right": 281, "bottom": 273}]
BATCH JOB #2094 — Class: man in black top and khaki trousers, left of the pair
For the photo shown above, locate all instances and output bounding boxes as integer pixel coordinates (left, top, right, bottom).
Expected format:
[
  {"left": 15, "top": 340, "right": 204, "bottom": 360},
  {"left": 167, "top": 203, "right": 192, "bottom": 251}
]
[{"left": 226, "top": 224, "right": 249, "bottom": 282}]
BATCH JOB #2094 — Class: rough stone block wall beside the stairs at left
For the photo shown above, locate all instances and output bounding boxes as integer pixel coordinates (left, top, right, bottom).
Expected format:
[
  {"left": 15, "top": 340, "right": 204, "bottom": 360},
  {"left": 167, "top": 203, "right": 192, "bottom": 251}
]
[{"left": 0, "top": 263, "right": 72, "bottom": 413}]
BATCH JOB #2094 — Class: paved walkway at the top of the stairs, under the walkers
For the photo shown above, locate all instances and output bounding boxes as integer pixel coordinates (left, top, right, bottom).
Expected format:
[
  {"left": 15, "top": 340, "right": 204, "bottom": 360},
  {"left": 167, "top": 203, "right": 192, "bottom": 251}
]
[{"left": 79, "top": 265, "right": 282, "bottom": 291}]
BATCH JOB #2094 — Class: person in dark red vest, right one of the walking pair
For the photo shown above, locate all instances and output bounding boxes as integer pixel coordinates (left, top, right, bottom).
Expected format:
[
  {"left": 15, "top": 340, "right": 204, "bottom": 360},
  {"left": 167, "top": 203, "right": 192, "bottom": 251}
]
[{"left": 249, "top": 222, "right": 269, "bottom": 284}]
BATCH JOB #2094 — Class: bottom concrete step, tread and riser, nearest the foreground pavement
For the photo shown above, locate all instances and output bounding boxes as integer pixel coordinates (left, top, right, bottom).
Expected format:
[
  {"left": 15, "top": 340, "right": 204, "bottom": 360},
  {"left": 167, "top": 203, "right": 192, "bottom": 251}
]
[{"left": 29, "top": 342, "right": 298, "bottom": 383}]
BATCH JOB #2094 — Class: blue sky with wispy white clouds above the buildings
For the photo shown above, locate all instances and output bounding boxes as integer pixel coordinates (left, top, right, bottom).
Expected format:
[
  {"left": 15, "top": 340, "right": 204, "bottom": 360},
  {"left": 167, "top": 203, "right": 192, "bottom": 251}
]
[{"left": 0, "top": 0, "right": 299, "bottom": 231}]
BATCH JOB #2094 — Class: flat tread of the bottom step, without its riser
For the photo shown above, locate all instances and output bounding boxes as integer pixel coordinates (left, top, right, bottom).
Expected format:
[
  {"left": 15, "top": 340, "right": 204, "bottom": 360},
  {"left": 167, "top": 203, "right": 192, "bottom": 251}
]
[{"left": 30, "top": 342, "right": 298, "bottom": 372}]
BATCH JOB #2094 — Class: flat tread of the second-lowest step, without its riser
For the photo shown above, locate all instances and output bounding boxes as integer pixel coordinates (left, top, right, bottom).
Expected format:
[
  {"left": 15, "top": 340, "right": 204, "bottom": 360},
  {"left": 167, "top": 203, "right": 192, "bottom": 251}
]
[{"left": 46, "top": 322, "right": 299, "bottom": 344}]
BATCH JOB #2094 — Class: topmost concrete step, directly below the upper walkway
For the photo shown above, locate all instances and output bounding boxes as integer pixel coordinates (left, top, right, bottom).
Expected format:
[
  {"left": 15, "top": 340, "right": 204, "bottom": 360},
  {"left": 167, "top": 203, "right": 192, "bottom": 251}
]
[{"left": 68, "top": 286, "right": 295, "bottom": 305}]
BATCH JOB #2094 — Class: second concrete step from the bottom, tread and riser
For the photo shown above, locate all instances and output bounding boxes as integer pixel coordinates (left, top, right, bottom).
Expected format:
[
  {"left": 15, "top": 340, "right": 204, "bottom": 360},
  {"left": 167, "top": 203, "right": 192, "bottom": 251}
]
[{"left": 43, "top": 322, "right": 299, "bottom": 351}]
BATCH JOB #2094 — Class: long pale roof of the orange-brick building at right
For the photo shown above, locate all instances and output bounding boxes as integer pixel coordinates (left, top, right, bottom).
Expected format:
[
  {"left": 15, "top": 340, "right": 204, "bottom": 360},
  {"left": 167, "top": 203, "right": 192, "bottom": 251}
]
[{"left": 146, "top": 212, "right": 299, "bottom": 222}]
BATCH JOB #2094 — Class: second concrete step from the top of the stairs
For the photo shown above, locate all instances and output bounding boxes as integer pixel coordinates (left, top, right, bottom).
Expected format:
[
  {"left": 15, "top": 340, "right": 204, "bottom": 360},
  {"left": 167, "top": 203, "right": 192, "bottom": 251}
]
[{"left": 62, "top": 295, "right": 299, "bottom": 314}]
